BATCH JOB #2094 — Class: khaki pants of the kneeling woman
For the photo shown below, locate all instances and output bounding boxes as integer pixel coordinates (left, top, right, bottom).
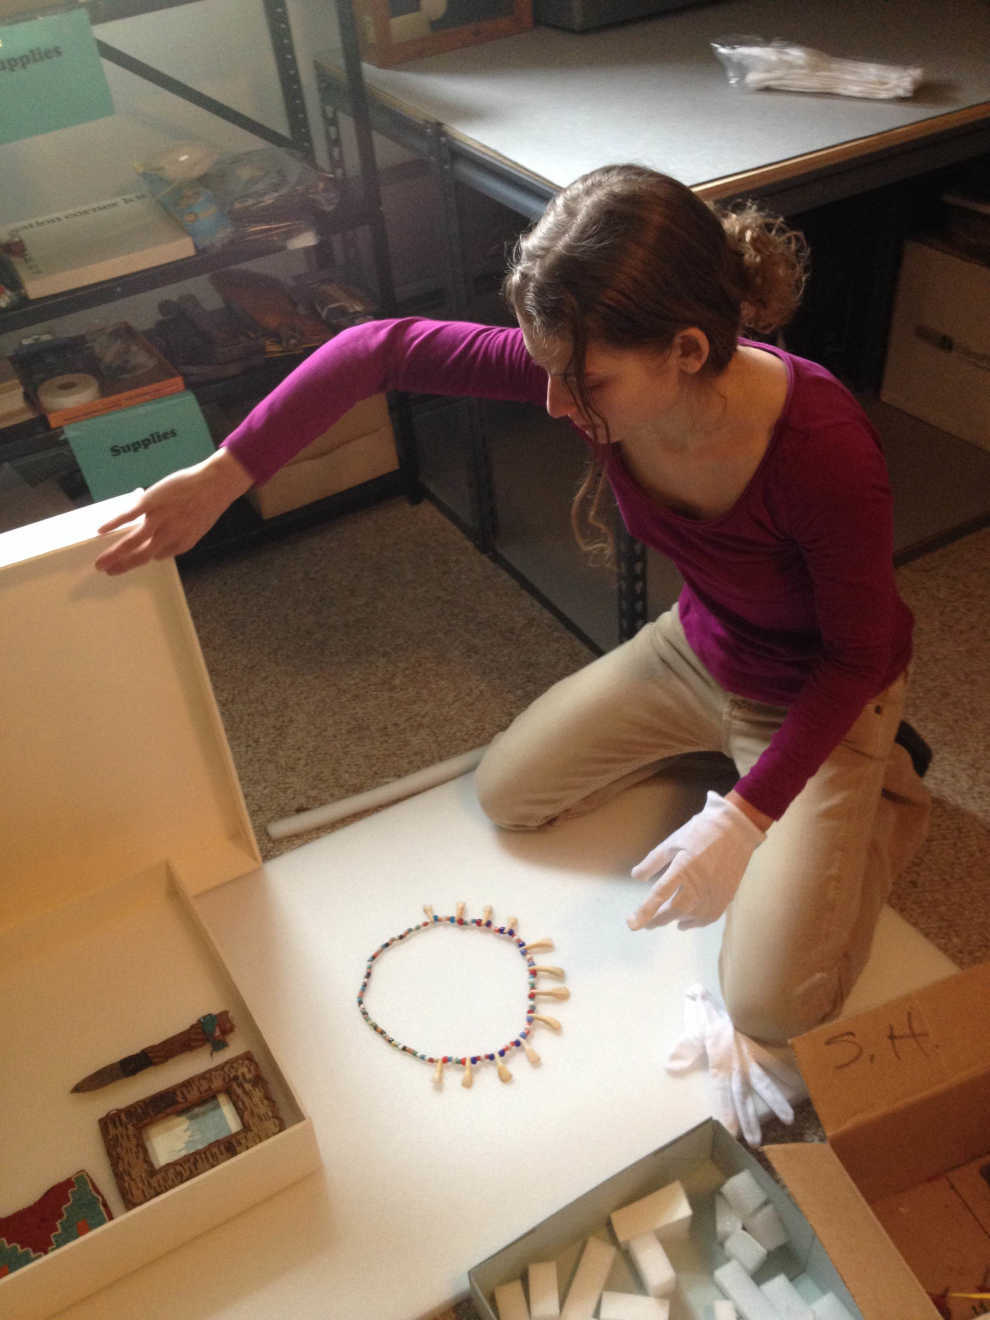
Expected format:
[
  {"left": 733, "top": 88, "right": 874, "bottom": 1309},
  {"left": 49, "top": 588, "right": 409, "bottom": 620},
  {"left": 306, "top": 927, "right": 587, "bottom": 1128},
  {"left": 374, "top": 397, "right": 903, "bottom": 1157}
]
[{"left": 475, "top": 606, "right": 929, "bottom": 1043}]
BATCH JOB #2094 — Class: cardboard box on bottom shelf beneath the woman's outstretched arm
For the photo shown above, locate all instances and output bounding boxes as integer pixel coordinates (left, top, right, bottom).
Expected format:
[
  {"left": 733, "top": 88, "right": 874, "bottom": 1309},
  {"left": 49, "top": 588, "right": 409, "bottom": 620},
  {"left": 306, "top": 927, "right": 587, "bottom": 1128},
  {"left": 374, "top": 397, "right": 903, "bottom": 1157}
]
[{"left": 248, "top": 395, "right": 399, "bottom": 517}]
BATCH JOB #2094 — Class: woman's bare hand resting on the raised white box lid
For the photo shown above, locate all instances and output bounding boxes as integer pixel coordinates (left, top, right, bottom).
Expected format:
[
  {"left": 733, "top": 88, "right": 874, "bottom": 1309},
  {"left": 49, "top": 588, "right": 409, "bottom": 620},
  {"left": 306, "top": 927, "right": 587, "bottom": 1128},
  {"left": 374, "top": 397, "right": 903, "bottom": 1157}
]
[{"left": 95, "top": 449, "right": 253, "bottom": 577}]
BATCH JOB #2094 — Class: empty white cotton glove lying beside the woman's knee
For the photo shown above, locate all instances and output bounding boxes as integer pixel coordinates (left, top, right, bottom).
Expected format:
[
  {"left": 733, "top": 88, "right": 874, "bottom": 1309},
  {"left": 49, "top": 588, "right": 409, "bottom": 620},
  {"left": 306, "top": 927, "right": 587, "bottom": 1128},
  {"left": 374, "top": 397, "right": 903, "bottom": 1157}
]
[{"left": 667, "top": 985, "right": 807, "bottom": 1146}]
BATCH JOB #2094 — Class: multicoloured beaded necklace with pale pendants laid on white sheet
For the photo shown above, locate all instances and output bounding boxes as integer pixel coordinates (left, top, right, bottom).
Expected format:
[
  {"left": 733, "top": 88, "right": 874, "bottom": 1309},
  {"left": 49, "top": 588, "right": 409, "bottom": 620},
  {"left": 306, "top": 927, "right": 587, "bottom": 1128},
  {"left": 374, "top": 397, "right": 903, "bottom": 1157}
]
[{"left": 358, "top": 903, "right": 570, "bottom": 1088}]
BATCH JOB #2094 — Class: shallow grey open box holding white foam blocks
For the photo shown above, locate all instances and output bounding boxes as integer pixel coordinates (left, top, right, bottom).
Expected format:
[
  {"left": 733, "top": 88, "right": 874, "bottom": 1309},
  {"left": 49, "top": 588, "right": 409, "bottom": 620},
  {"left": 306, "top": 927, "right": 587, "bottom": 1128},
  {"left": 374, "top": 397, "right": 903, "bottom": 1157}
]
[{"left": 467, "top": 1118, "right": 865, "bottom": 1320}]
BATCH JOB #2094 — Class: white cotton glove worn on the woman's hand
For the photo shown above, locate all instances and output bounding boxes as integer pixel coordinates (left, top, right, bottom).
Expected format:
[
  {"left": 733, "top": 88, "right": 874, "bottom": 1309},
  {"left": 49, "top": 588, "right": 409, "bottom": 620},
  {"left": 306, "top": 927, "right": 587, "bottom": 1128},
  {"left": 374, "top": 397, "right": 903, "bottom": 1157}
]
[{"left": 627, "top": 792, "right": 766, "bottom": 931}]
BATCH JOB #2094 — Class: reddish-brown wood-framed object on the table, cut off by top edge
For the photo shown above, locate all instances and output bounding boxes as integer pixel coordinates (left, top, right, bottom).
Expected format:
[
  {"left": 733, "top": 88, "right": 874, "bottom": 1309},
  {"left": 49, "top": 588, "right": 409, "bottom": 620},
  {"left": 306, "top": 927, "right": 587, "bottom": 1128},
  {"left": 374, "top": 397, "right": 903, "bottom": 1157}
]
[{"left": 355, "top": 0, "right": 533, "bottom": 69}]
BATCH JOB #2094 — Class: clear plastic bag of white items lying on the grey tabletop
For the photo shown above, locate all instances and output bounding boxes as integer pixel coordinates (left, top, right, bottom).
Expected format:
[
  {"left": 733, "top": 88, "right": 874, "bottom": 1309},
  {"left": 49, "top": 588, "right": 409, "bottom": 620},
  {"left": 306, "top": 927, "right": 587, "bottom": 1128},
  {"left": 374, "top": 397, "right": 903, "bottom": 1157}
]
[{"left": 711, "top": 37, "right": 924, "bottom": 100}]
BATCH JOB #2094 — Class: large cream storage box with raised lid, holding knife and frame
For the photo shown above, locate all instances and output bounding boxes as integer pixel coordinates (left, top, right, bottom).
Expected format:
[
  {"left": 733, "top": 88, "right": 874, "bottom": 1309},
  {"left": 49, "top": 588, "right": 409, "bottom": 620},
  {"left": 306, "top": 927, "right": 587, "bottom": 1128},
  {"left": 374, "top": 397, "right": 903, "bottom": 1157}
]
[{"left": 0, "top": 495, "right": 319, "bottom": 1320}]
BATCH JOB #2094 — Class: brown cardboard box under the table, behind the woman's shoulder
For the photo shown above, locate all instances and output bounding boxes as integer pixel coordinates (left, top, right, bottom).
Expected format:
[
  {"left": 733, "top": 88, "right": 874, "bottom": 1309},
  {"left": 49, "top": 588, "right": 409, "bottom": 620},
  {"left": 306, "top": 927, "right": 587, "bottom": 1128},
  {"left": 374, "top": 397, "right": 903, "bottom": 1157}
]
[{"left": 880, "top": 239, "right": 990, "bottom": 449}]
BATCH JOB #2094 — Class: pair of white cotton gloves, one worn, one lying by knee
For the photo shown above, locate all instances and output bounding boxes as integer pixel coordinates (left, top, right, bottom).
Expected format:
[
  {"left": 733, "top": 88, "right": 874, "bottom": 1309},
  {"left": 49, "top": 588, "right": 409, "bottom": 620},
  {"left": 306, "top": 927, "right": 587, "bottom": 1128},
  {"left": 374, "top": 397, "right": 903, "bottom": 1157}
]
[{"left": 628, "top": 792, "right": 804, "bottom": 1146}]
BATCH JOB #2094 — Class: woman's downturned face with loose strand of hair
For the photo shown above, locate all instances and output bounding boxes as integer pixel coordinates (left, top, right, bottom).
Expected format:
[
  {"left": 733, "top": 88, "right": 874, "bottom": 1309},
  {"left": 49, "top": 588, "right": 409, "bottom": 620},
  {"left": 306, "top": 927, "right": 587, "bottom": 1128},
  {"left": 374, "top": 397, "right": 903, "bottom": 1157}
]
[{"left": 523, "top": 331, "right": 684, "bottom": 445}]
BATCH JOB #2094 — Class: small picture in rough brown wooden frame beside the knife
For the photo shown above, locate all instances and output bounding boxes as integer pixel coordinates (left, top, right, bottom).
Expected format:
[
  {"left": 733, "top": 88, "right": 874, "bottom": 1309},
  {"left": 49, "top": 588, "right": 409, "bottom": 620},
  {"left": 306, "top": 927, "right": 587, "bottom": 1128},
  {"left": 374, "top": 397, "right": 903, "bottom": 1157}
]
[{"left": 100, "top": 1053, "right": 284, "bottom": 1210}]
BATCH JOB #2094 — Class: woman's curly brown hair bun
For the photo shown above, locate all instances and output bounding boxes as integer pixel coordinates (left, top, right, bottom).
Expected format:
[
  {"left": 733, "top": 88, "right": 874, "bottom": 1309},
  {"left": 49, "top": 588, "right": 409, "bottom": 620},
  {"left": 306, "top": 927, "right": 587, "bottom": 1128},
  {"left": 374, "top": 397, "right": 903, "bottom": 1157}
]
[{"left": 718, "top": 202, "right": 810, "bottom": 334}]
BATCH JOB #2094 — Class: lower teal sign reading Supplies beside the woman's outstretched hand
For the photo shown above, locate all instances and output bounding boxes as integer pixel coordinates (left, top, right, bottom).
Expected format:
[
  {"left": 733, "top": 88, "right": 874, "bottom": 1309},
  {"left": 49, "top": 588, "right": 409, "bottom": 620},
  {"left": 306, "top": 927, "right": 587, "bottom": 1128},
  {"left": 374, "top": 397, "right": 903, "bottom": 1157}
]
[{"left": 63, "top": 391, "right": 214, "bottom": 500}]
